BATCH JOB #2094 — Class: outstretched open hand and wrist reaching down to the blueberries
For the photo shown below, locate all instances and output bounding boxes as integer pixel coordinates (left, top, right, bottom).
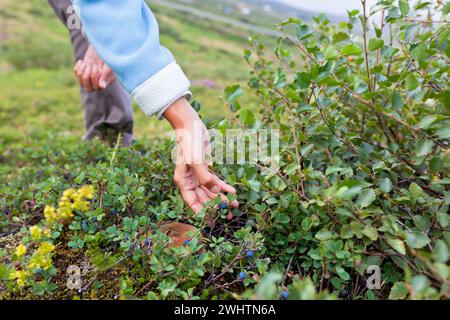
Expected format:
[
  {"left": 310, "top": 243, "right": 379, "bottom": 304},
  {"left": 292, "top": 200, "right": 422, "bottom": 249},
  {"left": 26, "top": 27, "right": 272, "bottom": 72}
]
[{"left": 164, "top": 98, "right": 239, "bottom": 213}]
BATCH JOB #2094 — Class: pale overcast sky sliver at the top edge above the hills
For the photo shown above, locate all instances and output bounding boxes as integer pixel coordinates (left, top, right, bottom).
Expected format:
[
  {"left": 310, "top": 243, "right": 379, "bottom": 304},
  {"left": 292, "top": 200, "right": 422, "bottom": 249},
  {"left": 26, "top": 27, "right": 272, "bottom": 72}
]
[{"left": 276, "top": 0, "right": 377, "bottom": 15}]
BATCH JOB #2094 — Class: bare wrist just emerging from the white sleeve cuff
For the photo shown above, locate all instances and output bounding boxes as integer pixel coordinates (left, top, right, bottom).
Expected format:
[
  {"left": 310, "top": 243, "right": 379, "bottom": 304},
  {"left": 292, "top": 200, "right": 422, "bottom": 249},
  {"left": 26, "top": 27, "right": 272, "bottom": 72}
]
[{"left": 164, "top": 98, "right": 200, "bottom": 130}]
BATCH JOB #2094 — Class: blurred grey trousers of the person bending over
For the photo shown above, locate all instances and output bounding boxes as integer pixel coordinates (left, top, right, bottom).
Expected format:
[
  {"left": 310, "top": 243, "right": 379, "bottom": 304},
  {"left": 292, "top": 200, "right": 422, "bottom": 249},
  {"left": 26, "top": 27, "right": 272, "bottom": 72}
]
[{"left": 48, "top": 0, "right": 134, "bottom": 146}]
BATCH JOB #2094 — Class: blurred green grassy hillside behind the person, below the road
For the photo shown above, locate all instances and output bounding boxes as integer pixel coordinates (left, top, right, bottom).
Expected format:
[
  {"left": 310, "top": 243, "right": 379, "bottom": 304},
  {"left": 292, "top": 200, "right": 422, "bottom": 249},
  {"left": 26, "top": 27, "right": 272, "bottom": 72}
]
[{"left": 0, "top": 0, "right": 284, "bottom": 151}]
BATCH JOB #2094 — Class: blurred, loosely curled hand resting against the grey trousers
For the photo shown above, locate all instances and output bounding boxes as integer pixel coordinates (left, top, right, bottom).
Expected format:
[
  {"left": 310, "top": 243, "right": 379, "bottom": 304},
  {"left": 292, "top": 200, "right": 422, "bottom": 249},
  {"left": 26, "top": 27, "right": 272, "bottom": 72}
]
[{"left": 73, "top": 45, "right": 116, "bottom": 92}]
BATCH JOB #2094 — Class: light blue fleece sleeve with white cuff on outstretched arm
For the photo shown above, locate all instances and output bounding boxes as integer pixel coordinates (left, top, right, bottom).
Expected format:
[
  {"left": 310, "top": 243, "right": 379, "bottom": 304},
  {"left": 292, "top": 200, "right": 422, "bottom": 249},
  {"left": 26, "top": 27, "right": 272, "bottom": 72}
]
[{"left": 73, "top": 0, "right": 190, "bottom": 116}]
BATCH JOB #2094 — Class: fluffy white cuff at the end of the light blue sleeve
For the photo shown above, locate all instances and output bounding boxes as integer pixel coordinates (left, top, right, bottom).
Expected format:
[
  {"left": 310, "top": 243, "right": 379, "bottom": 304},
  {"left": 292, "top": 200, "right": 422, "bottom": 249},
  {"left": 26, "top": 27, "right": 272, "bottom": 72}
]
[{"left": 131, "top": 62, "right": 192, "bottom": 118}]
